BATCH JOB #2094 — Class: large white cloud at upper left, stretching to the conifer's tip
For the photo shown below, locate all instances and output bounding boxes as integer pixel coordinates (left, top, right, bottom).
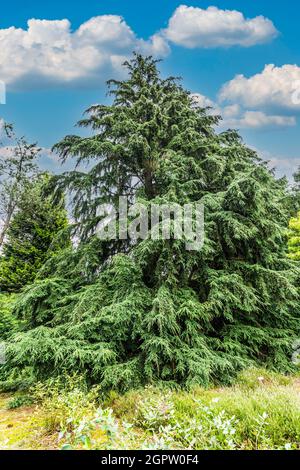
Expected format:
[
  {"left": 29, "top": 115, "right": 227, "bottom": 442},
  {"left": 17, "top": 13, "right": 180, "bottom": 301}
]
[{"left": 0, "top": 15, "right": 169, "bottom": 89}]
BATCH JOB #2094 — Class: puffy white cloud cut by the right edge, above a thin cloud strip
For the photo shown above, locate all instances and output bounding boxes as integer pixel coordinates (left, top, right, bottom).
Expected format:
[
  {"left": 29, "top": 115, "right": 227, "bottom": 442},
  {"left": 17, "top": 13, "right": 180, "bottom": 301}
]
[{"left": 220, "top": 65, "right": 300, "bottom": 111}]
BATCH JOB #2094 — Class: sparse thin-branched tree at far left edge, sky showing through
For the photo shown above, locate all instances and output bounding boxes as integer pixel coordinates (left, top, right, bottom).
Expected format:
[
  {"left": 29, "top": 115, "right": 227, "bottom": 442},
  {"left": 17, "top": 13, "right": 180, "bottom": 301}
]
[{"left": 0, "top": 124, "right": 40, "bottom": 249}]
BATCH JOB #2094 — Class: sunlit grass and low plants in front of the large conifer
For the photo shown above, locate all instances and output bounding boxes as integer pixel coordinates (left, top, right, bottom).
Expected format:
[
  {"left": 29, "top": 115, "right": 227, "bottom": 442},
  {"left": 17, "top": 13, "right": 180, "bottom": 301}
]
[{"left": 0, "top": 369, "right": 300, "bottom": 450}]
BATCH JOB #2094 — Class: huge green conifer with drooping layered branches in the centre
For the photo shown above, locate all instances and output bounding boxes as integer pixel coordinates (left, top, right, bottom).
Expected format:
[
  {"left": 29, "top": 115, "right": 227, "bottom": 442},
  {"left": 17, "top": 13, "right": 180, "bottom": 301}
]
[{"left": 7, "top": 55, "right": 300, "bottom": 390}]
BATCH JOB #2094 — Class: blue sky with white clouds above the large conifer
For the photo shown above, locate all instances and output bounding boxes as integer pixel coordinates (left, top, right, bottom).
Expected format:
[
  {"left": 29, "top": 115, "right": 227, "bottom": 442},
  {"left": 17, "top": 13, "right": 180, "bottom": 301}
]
[{"left": 0, "top": 0, "right": 300, "bottom": 175}]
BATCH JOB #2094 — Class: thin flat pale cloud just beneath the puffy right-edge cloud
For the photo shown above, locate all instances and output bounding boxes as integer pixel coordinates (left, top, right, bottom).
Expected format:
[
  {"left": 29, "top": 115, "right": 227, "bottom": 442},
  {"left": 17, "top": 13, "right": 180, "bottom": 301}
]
[{"left": 192, "top": 93, "right": 297, "bottom": 129}]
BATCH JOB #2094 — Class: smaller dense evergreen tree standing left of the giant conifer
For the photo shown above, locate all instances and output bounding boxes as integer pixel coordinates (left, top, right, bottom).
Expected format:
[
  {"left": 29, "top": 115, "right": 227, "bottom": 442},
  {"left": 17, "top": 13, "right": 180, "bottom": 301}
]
[{"left": 0, "top": 175, "right": 67, "bottom": 292}]
